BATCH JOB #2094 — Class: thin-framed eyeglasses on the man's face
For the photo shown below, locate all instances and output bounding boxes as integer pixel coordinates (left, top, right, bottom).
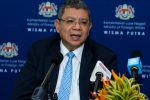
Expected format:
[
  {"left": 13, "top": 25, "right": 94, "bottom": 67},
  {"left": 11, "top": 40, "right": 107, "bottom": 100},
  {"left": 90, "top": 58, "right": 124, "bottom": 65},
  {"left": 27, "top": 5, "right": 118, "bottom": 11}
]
[{"left": 58, "top": 18, "right": 90, "bottom": 27}]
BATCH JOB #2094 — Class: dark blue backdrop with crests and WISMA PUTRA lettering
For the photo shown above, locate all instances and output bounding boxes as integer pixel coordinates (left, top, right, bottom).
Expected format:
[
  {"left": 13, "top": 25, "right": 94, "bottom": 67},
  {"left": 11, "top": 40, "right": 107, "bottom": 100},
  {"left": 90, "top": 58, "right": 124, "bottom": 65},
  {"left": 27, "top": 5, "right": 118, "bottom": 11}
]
[{"left": 0, "top": 0, "right": 150, "bottom": 100}]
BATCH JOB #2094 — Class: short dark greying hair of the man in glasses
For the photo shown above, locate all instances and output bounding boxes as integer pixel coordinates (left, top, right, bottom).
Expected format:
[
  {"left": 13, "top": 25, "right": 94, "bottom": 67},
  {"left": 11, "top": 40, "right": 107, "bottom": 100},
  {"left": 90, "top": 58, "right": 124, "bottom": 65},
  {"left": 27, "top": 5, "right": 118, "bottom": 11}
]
[{"left": 58, "top": 0, "right": 91, "bottom": 21}]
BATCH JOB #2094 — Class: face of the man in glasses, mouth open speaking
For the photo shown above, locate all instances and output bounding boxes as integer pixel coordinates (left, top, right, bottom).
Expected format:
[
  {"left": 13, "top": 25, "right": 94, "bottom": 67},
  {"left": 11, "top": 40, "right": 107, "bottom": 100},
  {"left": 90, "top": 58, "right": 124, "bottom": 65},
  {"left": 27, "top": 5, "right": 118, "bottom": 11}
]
[{"left": 55, "top": 8, "right": 92, "bottom": 50}]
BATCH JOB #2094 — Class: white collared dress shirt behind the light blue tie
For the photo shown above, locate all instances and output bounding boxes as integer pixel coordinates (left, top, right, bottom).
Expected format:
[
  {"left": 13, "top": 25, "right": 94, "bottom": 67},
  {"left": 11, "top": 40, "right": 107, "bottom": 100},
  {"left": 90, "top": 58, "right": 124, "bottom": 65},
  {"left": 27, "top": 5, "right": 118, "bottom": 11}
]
[{"left": 55, "top": 41, "right": 84, "bottom": 100}]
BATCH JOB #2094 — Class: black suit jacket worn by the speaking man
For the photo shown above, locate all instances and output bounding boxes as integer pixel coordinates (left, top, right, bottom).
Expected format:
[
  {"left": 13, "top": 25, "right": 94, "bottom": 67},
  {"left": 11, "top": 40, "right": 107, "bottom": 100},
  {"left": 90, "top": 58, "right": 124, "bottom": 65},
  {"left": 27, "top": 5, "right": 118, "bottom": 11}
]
[{"left": 12, "top": 36, "right": 116, "bottom": 100}]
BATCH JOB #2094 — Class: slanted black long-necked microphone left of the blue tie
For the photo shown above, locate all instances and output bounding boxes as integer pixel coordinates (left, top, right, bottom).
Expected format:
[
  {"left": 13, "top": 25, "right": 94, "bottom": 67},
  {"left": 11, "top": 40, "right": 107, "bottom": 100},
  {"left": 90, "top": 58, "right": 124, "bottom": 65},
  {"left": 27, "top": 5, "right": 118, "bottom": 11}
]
[{"left": 31, "top": 53, "right": 63, "bottom": 100}]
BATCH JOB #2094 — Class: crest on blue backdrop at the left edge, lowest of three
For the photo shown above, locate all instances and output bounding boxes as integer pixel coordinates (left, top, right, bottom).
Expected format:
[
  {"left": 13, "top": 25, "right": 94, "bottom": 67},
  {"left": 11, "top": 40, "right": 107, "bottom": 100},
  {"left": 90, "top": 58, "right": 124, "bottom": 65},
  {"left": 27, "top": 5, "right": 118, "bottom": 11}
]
[{"left": 0, "top": 42, "right": 18, "bottom": 58}]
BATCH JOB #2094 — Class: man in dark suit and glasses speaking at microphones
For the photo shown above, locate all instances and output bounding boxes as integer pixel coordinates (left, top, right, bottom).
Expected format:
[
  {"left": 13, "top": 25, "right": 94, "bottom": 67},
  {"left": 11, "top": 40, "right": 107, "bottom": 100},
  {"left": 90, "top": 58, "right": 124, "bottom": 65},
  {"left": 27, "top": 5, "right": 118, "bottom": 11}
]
[{"left": 13, "top": 0, "right": 116, "bottom": 100}]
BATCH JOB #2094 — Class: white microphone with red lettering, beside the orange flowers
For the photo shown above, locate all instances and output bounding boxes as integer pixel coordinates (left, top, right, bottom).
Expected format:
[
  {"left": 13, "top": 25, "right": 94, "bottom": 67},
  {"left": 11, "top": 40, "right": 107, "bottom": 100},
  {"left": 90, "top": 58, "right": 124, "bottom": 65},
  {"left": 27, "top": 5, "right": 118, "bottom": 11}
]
[{"left": 90, "top": 60, "right": 111, "bottom": 97}]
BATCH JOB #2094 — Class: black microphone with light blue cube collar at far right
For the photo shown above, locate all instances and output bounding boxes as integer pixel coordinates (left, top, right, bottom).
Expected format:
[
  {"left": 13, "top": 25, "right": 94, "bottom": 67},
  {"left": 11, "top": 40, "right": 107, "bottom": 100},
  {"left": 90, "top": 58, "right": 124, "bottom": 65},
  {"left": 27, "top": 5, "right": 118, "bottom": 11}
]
[{"left": 127, "top": 50, "right": 142, "bottom": 79}]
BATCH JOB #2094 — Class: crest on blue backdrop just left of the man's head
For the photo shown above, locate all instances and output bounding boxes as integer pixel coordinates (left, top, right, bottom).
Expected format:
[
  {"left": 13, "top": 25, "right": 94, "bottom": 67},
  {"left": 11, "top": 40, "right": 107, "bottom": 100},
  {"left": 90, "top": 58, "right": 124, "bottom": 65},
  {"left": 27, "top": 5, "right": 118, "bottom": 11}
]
[{"left": 39, "top": 1, "right": 57, "bottom": 17}]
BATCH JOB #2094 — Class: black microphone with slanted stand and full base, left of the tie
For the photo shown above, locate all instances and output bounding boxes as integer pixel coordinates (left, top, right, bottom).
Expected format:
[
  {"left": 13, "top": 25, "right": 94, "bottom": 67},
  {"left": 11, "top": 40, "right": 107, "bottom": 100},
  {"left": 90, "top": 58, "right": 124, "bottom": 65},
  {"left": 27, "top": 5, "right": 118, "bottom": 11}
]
[{"left": 31, "top": 52, "right": 63, "bottom": 100}]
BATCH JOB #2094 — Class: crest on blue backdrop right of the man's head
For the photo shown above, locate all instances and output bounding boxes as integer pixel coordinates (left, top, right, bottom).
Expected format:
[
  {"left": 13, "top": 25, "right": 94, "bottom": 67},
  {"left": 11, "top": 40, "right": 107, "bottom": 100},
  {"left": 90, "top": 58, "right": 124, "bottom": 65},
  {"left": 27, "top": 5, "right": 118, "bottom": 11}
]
[{"left": 115, "top": 4, "right": 135, "bottom": 20}]
